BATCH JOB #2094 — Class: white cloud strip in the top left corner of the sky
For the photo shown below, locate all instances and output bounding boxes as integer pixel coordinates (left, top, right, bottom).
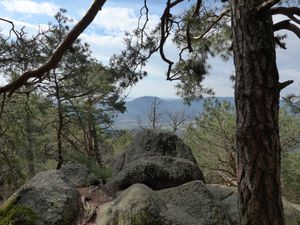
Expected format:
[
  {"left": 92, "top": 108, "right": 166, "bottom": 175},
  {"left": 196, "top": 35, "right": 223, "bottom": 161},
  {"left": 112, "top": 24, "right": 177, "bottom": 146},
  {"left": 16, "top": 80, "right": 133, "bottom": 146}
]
[{"left": 1, "top": 0, "right": 59, "bottom": 16}]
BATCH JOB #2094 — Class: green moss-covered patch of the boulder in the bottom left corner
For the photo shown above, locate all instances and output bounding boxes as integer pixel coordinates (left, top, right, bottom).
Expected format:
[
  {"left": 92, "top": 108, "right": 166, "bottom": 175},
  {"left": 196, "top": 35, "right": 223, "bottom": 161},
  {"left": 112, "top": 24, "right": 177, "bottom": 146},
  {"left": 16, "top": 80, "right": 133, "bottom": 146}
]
[{"left": 0, "top": 197, "right": 37, "bottom": 225}]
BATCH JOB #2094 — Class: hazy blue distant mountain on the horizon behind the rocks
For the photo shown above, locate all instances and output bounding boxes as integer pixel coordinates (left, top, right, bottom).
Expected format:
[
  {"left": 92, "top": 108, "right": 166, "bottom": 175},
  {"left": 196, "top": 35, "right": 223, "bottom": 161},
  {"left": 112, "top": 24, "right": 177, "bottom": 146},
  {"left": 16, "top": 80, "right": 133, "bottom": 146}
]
[{"left": 114, "top": 96, "right": 234, "bottom": 129}]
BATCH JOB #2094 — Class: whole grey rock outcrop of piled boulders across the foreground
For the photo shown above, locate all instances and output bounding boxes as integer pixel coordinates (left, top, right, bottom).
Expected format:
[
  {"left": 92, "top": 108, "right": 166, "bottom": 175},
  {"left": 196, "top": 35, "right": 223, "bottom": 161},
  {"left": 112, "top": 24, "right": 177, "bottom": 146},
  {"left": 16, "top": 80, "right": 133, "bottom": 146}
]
[{"left": 0, "top": 131, "right": 300, "bottom": 225}]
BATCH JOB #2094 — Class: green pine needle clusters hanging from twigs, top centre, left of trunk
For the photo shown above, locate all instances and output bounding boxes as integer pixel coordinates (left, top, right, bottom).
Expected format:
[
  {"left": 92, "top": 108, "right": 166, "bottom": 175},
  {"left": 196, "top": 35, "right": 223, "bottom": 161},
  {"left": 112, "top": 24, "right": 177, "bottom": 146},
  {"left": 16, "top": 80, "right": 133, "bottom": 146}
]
[{"left": 111, "top": 2, "right": 232, "bottom": 102}]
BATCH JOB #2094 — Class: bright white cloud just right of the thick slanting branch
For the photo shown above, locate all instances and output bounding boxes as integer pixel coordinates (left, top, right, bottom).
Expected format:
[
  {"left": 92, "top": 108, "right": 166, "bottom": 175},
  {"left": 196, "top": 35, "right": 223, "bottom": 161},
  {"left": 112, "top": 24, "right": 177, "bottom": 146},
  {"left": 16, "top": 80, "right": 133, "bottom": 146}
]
[{"left": 80, "top": 7, "right": 159, "bottom": 63}]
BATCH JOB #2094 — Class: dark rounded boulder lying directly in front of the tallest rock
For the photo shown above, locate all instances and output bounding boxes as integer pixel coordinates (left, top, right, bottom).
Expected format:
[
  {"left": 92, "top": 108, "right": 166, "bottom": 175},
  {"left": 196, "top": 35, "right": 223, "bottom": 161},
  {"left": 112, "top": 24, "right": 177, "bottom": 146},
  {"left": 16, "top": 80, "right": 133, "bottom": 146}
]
[{"left": 108, "top": 156, "right": 203, "bottom": 190}]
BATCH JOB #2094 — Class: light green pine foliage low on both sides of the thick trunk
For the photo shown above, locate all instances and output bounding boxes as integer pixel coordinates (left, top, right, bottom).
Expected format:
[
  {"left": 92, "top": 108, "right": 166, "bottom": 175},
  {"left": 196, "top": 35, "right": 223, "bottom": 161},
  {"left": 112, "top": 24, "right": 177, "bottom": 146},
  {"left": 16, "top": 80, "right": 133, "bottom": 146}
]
[{"left": 184, "top": 99, "right": 300, "bottom": 187}]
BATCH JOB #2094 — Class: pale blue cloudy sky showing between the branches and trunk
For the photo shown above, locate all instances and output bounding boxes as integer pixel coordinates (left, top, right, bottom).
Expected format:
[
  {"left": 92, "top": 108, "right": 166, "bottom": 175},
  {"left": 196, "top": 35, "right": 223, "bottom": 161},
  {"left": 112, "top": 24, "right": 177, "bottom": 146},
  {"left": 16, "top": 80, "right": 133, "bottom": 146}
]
[{"left": 0, "top": 0, "right": 300, "bottom": 98}]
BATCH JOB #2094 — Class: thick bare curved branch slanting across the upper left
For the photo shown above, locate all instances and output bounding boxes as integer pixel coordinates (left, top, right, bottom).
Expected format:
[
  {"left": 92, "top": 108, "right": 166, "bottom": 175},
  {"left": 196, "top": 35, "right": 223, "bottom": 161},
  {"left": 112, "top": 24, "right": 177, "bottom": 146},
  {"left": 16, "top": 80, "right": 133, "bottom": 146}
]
[{"left": 0, "top": 0, "right": 106, "bottom": 95}]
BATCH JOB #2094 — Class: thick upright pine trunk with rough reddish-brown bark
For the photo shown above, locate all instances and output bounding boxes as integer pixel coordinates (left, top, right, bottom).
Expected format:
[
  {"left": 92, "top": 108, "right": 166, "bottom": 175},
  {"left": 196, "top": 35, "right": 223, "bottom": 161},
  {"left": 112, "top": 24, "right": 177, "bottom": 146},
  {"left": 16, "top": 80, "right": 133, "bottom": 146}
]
[{"left": 232, "top": 0, "right": 284, "bottom": 225}]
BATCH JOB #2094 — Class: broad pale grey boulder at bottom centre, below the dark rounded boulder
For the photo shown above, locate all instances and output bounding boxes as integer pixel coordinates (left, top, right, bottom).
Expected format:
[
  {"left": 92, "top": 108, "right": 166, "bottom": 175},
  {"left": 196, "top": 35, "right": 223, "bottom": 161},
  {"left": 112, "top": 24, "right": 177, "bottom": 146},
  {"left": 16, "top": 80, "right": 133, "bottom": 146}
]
[{"left": 96, "top": 181, "right": 232, "bottom": 225}]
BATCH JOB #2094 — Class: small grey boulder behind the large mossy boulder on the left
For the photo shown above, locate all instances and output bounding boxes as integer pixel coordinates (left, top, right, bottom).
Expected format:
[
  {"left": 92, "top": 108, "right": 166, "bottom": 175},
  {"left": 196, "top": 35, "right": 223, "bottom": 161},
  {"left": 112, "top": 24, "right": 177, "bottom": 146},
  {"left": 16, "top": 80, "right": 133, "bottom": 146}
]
[{"left": 60, "top": 163, "right": 102, "bottom": 187}]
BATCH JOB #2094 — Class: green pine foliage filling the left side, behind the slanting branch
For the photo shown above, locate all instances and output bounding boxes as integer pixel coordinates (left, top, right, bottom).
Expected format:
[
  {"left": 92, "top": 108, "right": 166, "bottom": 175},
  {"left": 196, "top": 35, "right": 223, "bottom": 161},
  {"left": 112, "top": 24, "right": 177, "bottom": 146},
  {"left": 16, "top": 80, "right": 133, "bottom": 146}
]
[{"left": 0, "top": 9, "right": 125, "bottom": 198}]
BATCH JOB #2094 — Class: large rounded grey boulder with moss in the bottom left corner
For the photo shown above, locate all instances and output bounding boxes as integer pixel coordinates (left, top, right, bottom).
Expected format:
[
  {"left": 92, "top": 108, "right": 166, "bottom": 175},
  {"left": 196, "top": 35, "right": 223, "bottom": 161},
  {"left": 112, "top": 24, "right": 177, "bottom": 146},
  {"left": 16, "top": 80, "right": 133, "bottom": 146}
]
[{"left": 0, "top": 170, "right": 78, "bottom": 225}]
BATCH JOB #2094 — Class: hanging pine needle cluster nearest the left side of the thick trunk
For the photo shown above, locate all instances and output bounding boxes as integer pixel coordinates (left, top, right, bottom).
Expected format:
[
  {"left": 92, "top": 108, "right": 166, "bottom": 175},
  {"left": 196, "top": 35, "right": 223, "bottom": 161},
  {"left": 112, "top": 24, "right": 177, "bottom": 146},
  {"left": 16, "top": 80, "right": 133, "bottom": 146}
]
[{"left": 172, "top": 3, "right": 232, "bottom": 102}]
